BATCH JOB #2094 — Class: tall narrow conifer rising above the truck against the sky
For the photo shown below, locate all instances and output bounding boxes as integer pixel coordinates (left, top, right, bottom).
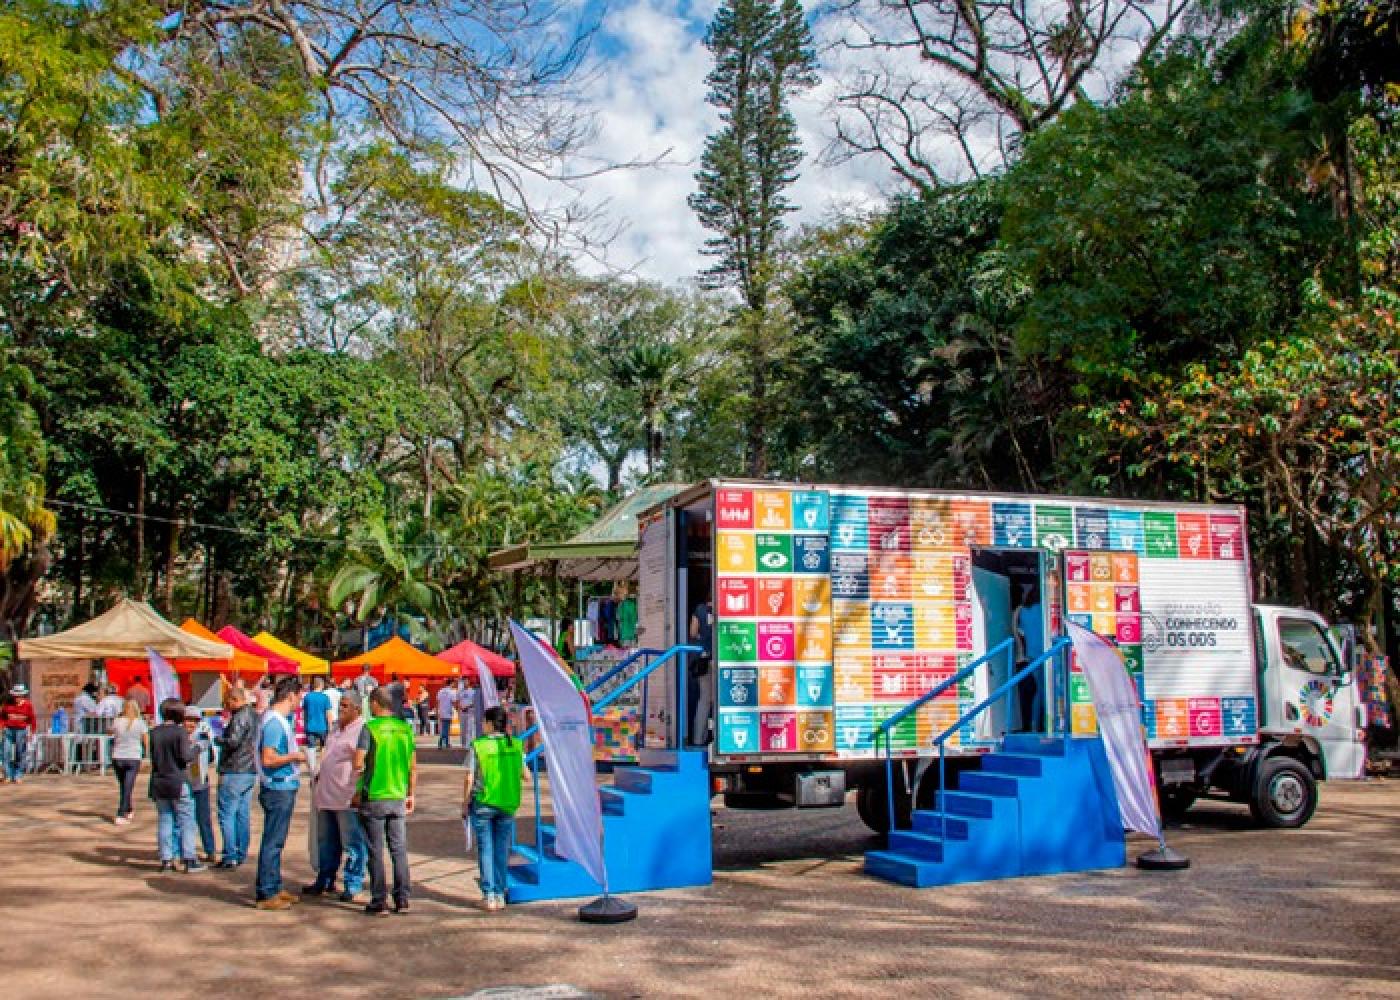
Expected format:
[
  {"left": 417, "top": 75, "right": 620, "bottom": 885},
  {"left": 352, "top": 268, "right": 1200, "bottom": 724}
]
[{"left": 690, "top": 0, "right": 816, "bottom": 476}]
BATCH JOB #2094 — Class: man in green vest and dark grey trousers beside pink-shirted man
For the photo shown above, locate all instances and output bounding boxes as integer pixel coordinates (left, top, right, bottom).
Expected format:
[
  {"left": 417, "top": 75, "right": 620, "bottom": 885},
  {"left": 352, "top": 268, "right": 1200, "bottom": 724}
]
[{"left": 354, "top": 688, "right": 419, "bottom": 916}]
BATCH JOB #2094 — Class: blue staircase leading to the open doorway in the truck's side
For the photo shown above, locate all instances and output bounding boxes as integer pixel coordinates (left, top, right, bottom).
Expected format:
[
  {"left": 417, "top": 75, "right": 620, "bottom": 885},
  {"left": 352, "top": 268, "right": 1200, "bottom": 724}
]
[{"left": 865, "top": 735, "right": 1126, "bottom": 888}]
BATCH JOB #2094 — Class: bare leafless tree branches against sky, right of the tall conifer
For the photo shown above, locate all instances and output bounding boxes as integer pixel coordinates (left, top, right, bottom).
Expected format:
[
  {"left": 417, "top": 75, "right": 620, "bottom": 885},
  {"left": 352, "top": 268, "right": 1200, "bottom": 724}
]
[{"left": 834, "top": 0, "right": 1196, "bottom": 188}]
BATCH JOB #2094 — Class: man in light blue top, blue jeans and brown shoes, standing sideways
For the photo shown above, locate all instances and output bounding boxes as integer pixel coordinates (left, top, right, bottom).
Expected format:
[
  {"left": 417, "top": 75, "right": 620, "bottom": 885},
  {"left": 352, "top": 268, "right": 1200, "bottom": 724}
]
[{"left": 253, "top": 676, "right": 307, "bottom": 910}]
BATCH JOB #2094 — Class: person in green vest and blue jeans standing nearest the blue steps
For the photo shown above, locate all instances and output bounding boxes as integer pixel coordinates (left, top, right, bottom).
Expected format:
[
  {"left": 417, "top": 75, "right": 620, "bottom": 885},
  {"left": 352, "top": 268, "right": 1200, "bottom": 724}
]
[{"left": 462, "top": 706, "right": 524, "bottom": 912}]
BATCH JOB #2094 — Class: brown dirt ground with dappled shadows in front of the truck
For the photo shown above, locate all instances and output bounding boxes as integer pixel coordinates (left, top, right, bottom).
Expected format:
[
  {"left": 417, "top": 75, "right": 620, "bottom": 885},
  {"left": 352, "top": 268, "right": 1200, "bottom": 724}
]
[{"left": 0, "top": 755, "right": 1400, "bottom": 1000}]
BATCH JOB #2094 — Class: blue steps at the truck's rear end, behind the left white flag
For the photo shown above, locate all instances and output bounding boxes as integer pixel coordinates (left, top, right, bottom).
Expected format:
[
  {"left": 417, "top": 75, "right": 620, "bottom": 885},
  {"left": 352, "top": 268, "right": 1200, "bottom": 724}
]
[{"left": 507, "top": 749, "right": 714, "bottom": 903}]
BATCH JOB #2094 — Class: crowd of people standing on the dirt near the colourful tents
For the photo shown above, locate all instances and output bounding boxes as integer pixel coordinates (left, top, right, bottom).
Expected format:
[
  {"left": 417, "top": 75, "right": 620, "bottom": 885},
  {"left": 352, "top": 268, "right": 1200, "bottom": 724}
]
[{"left": 0, "top": 668, "right": 524, "bottom": 916}]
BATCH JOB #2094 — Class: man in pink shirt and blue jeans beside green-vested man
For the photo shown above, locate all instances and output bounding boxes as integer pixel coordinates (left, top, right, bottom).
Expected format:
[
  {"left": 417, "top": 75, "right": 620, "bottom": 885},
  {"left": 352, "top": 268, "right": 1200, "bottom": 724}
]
[{"left": 301, "top": 690, "right": 370, "bottom": 903}]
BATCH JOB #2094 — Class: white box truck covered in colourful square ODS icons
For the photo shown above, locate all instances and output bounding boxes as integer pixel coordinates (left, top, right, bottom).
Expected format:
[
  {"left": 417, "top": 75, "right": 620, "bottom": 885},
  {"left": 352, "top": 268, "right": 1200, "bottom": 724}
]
[{"left": 638, "top": 480, "right": 1365, "bottom": 832}]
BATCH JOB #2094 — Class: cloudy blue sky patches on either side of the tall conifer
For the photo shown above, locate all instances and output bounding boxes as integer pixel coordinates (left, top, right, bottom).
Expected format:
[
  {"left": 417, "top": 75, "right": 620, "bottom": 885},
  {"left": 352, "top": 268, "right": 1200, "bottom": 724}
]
[{"left": 548, "top": 0, "right": 892, "bottom": 283}]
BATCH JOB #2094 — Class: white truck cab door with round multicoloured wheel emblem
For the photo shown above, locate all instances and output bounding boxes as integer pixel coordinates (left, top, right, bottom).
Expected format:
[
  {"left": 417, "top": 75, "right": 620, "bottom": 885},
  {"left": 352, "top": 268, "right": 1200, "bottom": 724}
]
[{"left": 1274, "top": 612, "right": 1365, "bottom": 777}]
